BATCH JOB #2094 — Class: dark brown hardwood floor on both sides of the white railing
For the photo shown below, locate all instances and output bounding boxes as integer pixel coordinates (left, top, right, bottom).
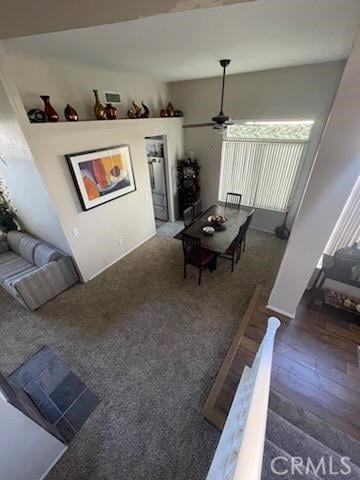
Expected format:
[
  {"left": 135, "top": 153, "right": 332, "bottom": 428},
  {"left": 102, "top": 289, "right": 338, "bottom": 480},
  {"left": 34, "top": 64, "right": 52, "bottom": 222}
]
[{"left": 203, "top": 289, "right": 360, "bottom": 440}]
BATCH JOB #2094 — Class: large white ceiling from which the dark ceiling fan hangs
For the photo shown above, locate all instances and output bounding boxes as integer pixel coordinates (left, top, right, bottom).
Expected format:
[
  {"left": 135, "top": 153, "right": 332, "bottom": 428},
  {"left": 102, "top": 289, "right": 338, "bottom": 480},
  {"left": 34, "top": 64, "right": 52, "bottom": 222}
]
[{"left": 1, "top": 0, "right": 360, "bottom": 81}]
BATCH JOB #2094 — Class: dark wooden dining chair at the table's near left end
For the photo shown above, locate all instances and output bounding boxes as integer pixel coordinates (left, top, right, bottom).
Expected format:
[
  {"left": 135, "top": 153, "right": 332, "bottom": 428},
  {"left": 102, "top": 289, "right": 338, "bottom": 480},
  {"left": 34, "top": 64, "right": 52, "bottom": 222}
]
[{"left": 182, "top": 233, "right": 217, "bottom": 285}]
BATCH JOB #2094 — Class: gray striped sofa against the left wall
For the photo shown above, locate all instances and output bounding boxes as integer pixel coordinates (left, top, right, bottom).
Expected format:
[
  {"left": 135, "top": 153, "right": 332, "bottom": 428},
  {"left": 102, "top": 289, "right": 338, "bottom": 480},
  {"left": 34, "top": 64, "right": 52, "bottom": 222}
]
[{"left": 0, "top": 230, "right": 78, "bottom": 310}]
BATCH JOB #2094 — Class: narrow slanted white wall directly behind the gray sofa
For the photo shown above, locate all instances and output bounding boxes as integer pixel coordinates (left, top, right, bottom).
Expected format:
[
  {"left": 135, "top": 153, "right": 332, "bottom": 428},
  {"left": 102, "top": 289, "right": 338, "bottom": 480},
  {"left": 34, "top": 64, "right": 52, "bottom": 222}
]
[{"left": 0, "top": 52, "right": 71, "bottom": 253}]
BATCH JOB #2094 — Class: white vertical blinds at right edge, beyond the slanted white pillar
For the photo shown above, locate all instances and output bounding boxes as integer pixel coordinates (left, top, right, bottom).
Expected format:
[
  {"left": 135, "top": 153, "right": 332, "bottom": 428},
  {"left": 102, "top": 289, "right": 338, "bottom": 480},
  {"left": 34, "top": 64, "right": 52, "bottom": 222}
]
[{"left": 324, "top": 177, "right": 360, "bottom": 255}]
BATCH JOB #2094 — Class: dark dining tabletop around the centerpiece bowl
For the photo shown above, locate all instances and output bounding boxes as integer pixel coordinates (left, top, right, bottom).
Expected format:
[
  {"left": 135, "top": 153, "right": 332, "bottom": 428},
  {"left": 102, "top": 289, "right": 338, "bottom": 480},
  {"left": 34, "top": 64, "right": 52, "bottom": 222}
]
[{"left": 184, "top": 205, "right": 249, "bottom": 255}]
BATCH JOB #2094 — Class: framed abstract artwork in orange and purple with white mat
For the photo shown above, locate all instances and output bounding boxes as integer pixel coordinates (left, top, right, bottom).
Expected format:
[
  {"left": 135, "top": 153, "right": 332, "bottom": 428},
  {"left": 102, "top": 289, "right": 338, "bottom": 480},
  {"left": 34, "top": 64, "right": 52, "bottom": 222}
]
[{"left": 65, "top": 145, "right": 136, "bottom": 210}]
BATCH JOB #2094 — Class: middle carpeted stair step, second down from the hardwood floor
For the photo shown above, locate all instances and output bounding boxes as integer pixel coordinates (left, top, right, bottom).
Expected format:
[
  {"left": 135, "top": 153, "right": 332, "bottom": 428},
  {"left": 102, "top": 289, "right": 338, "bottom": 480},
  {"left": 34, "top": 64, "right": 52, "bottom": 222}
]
[{"left": 266, "top": 410, "right": 360, "bottom": 480}]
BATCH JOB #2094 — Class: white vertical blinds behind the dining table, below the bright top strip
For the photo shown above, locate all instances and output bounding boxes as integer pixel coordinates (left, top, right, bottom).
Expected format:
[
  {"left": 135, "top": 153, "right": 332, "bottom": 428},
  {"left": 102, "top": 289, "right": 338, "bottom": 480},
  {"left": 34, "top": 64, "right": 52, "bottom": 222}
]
[{"left": 219, "top": 140, "right": 307, "bottom": 212}]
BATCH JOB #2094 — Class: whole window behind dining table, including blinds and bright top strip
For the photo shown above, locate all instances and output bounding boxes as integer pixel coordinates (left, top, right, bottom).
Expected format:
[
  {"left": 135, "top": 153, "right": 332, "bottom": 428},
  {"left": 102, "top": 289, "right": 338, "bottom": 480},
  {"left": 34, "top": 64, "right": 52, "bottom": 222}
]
[{"left": 219, "top": 121, "right": 313, "bottom": 212}]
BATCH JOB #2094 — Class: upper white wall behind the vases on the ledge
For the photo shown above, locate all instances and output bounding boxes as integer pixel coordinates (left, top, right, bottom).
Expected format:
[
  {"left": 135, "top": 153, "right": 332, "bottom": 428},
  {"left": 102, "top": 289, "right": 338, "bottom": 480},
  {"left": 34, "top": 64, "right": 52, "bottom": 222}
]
[{"left": 6, "top": 55, "right": 169, "bottom": 120}]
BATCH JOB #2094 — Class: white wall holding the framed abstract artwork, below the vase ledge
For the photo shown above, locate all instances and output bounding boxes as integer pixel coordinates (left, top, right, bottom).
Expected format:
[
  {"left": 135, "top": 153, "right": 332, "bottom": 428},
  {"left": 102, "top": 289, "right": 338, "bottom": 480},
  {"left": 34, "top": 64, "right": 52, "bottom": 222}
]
[{"left": 27, "top": 118, "right": 183, "bottom": 281}]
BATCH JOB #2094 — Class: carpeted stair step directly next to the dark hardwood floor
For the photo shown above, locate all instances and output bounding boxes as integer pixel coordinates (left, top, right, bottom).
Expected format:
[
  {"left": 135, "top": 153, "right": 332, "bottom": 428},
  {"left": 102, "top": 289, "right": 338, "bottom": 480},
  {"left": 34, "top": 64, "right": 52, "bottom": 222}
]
[{"left": 269, "top": 389, "right": 360, "bottom": 467}]
